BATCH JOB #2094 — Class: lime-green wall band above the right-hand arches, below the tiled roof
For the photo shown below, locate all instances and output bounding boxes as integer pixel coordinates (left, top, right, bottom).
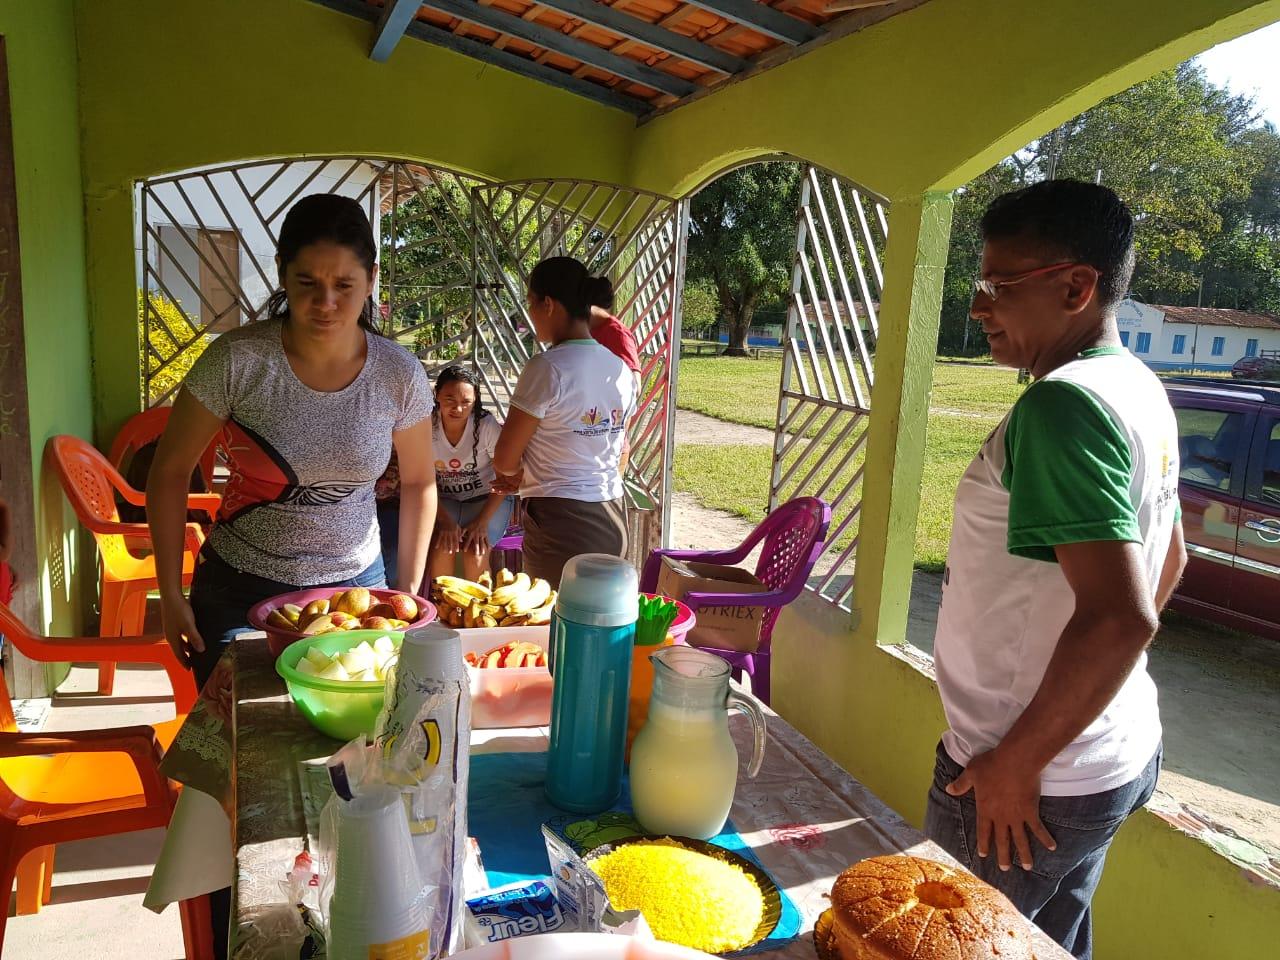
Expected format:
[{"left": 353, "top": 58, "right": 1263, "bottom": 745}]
[{"left": 631, "top": 0, "right": 1280, "bottom": 200}]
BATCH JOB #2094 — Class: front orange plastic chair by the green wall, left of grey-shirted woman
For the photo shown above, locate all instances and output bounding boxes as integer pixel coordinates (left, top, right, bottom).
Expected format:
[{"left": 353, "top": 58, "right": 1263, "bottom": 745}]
[{"left": 45, "top": 434, "right": 220, "bottom": 695}]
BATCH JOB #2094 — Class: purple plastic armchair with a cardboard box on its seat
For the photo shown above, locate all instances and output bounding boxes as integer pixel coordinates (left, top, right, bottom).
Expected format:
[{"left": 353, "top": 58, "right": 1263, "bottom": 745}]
[{"left": 640, "top": 497, "right": 831, "bottom": 703}]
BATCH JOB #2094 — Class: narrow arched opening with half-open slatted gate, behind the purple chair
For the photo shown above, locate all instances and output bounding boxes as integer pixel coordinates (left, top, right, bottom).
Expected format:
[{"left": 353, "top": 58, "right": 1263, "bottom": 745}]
[{"left": 673, "top": 159, "right": 888, "bottom": 612}]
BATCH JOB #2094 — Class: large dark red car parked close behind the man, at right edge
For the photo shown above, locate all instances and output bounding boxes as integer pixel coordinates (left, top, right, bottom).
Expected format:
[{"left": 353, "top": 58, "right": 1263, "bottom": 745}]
[{"left": 1165, "top": 378, "right": 1280, "bottom": 640}]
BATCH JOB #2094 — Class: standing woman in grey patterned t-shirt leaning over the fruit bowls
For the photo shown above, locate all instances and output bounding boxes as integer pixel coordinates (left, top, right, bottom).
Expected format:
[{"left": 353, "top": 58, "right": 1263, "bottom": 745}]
[{"left": 147, "top": 195, "right": 435, "bottom": 686}]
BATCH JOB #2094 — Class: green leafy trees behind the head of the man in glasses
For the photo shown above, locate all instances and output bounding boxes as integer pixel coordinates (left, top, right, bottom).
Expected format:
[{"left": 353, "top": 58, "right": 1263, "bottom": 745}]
[{"left": 940, "top": 61, "right": 1280, "bottom": 352}]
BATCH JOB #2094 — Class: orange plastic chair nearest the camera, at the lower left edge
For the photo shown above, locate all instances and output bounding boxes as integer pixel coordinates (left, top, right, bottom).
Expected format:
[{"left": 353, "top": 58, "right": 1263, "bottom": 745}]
[{"left": 0, "top": 673, "right": 212, "bottom": 960}]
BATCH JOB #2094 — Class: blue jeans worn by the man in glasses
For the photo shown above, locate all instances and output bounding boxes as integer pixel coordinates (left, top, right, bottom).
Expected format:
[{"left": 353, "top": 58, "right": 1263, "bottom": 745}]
[{"left": 924, "top": 744, "right": 1164, "bottom": 960}]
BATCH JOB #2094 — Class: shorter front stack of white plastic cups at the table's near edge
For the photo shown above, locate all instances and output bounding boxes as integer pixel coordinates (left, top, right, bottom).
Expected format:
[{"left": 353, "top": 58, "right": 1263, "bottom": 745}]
[{"left": 329, "top": 787, "right": 429, "bottom": 960}]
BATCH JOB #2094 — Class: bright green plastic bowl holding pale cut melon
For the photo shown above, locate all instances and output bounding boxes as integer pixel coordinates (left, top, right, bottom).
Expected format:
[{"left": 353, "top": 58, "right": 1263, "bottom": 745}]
[{"left": 275, "top": 630, "right": 404, "bottom": 741}]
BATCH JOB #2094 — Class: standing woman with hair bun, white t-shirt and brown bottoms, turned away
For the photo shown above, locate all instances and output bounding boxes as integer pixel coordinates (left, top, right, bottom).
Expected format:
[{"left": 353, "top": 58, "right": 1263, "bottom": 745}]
[{"left": 493, "top": 257, "right": 637, "bottom": 588}]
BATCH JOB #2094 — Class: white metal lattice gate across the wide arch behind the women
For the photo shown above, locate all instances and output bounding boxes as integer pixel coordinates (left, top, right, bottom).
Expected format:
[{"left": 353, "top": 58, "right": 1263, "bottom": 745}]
[{"left": 138, "top": 156, "right": 687, "bottom": 549}]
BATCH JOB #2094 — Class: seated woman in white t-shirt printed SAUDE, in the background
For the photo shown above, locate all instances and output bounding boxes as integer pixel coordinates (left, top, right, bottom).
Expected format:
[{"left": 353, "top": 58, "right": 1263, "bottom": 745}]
[{"left": 430, "top": 365, "right": 515, "bottom": 580}]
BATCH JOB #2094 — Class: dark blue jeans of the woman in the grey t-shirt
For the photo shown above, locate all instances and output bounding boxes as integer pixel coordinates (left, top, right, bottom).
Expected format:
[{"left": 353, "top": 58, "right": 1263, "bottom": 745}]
[{"left": 191, "top": 547, "right": 387, "bottom": 689}]
